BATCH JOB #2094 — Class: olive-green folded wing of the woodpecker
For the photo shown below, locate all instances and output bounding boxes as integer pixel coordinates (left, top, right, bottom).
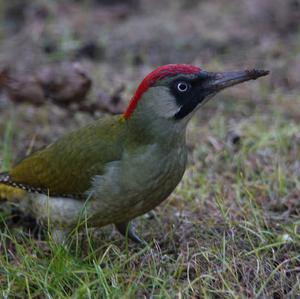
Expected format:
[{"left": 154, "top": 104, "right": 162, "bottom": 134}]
[{"left": 9, "top": 116, "right": 125, "bottom": 196}]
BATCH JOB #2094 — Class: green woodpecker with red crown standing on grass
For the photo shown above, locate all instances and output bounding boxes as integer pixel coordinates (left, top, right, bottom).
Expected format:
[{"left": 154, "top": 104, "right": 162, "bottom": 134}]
[{"left": 0, "top": 64, "right": 268, "bottom": 242}]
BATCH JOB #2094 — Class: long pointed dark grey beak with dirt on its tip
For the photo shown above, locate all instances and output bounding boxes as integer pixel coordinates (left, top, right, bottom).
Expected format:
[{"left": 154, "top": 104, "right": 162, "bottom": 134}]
[{"left": 200, "top": 69, "right": 269, "bottom": 94}]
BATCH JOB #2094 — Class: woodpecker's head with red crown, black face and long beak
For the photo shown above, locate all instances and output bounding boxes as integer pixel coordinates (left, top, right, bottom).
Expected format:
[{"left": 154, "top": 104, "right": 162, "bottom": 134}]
[{"left": 124, "top": 64, "right": 269, "bottom": 137}]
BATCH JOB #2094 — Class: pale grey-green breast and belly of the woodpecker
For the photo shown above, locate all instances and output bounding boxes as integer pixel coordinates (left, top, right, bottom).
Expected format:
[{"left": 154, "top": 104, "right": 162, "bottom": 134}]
[{"left": 91, "top": 145, "right": 187, "bottom": 224}]
